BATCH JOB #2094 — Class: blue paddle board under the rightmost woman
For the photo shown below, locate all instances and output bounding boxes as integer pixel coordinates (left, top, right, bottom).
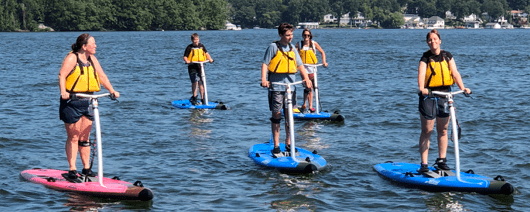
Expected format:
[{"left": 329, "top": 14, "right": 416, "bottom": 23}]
[{"left": 374, "top": 162, "right": 514, "bottom": 195}]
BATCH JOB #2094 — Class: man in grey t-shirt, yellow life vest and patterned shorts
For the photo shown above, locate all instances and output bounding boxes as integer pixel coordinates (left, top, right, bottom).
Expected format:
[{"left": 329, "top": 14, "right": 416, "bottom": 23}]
[{"left": 261, "top": 23, "right": 312, "bottom": 154}]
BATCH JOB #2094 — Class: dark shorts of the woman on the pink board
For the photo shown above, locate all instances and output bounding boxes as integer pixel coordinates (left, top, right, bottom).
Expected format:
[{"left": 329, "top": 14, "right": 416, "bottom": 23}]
[{"left": 59, "top": 97, "right": 94, "bottom": 124}]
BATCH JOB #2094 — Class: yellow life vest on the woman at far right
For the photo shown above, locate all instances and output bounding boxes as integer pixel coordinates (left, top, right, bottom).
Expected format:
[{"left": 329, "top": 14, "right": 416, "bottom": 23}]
[{"left": 425, "top": 52, "right": 454, "bottom": 88}]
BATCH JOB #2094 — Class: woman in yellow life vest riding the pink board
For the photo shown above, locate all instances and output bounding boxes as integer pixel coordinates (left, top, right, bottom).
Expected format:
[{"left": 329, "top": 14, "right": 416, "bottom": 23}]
[{"left": 59, "top": 33, "right": 120, "bottom": 179}]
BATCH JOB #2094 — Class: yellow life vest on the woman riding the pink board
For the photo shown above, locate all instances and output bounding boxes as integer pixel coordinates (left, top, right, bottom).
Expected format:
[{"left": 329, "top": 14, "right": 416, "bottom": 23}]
[{"left": 65, "top": 53, "right": 101, "bottom": 93}]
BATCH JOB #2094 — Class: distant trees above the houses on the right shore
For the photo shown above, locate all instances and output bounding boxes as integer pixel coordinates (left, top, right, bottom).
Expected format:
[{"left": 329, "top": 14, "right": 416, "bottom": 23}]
[{"left": 228, "top": 0, "right": 530, "bottom": 28}]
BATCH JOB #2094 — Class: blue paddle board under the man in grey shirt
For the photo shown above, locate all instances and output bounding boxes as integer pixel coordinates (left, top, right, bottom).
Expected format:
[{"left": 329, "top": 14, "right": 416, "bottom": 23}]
[{"left": 248, "top": 142, "right": 327, "bottom": 173}]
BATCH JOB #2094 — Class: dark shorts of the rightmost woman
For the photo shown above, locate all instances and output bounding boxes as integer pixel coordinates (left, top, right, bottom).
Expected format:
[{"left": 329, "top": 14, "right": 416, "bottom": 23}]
[{"left": 418, "top": 95, "right": 449, "bottom": 120}]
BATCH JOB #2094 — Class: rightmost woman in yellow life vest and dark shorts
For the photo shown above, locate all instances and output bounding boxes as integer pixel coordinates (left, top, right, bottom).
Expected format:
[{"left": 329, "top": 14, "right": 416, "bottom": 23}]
[{"left": 418, "top": 29, "right": 471, "bottom": 172}]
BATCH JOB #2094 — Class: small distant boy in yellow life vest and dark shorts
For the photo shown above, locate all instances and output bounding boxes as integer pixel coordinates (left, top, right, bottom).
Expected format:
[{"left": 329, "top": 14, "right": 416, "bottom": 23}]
[{"left": 183, "top": 33, "right": 213, "bottom": 105}]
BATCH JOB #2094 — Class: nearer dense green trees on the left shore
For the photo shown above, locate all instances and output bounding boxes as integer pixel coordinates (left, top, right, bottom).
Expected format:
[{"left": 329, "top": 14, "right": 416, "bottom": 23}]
[{"left": 0, "top": 0, "right": 229, "bottom": 31}]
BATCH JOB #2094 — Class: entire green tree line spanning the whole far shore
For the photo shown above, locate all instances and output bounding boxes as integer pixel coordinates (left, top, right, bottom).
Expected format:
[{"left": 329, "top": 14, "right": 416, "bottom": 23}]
[{"left": 0, "top": 0, "right": 530, "bottom": 31}]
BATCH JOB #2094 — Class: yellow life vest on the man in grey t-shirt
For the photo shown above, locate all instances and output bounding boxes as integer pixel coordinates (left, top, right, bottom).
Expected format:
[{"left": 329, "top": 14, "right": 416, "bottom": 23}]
[{"left": 269, "top": 41, "right": 297, "bottom": 74}]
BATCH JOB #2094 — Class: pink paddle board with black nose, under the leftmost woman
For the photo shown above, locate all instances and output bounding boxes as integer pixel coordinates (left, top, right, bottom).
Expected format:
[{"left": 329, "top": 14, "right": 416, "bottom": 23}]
[{"left": 20, "top": 168, "right": 153, "bottom": 201}]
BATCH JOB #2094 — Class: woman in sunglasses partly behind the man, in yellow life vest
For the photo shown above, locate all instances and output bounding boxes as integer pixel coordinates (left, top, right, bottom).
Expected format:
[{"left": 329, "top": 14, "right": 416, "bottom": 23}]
[{"left": 296, "top": 29, "right": 328, "bottom": 112}]
